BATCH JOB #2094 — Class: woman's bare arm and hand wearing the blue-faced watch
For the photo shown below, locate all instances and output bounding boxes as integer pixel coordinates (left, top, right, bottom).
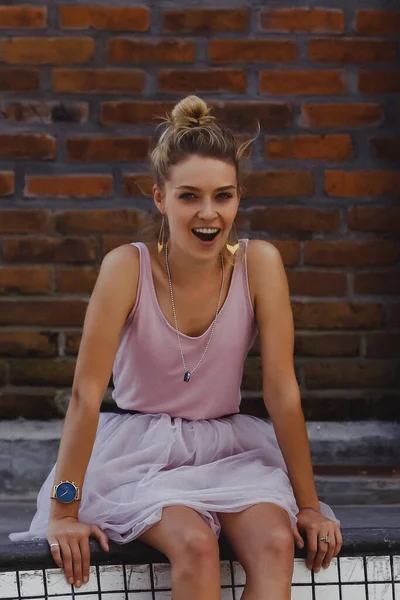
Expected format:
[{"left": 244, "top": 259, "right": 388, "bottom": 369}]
[{"left": 47, "top": 245, "right": 139, "bottom": 581}]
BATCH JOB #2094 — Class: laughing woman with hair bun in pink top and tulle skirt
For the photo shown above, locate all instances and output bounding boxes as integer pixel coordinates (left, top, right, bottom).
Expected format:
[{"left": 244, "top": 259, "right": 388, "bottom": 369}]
[{"left": 11, "top": 96, "right": 342, "bottom": 600}]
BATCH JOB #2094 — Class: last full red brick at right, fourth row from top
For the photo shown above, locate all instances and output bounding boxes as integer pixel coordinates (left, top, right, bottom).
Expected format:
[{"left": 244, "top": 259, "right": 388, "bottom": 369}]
[{"left": 300, "top": 103, "right": 384, "bottom": 127}]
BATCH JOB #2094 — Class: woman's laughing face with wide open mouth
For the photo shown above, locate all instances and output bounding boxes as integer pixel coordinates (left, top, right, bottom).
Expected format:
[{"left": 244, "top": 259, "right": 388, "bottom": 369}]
[{"left": 153, "top": 156, "right": 240, "bottom": 257}]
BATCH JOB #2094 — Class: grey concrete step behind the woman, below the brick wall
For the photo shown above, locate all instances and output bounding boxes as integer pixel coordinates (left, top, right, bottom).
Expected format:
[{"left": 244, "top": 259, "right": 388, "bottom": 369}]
[{"left": 0, "top": 420, "right": 400, "bottom": 504}]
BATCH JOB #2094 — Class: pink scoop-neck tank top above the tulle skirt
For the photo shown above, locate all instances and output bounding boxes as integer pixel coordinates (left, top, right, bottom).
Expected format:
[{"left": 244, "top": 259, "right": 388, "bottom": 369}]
[{"left": 112, "top": 239, "right": 257, "bottom": 420}]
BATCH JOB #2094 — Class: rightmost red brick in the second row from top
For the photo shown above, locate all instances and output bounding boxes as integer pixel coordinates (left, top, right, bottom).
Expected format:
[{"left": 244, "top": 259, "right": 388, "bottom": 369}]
[{"left": 307, "top": 38, "right": 397, "bottom": 63}]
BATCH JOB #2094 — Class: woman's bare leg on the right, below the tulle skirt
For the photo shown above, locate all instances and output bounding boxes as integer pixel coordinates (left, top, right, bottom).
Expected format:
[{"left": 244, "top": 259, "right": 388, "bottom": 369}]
[{"left": 218, "top": 503, "right": 294, "bottom": 600}]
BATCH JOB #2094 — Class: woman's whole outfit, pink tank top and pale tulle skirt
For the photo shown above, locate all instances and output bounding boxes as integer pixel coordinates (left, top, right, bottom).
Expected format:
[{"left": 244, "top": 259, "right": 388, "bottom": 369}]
[{"left": 10, "top": 239, "right": 337, "bottom": 544}]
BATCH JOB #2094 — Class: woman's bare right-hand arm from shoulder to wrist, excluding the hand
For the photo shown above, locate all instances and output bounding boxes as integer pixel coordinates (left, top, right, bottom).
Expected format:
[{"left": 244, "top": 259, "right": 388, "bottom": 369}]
[{"left": 248, "top": 240, "right": 319, "bottom": 510}]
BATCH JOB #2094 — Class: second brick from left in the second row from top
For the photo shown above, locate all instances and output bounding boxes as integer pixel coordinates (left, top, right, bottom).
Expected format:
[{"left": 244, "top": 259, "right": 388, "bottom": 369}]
[{"left": 108, "top": 38, "right": 196, "bottom": 63}]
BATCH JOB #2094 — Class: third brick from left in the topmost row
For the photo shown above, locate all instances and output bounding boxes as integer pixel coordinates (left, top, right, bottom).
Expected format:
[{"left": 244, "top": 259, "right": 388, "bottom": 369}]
[{"left": 163, "top": 8, "right": 250, "bottom": 34}]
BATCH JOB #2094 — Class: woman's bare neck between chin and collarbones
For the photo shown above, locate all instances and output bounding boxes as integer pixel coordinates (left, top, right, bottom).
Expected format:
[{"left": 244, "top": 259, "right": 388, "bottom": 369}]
[{"left": 164, "top": 242, "right": 221, "bottom": 287}]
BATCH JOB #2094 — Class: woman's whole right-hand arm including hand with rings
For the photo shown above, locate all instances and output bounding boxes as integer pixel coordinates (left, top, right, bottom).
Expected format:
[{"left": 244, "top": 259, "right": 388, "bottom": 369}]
[{"left": 248, "top": 241, "right": 342, "bottom": 573}]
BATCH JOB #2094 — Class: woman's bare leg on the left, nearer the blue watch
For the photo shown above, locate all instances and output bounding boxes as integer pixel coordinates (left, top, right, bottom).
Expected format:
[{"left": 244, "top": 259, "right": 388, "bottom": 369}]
[{"left": 139, "top": 506, "right": 221, "bottom": 600}]
